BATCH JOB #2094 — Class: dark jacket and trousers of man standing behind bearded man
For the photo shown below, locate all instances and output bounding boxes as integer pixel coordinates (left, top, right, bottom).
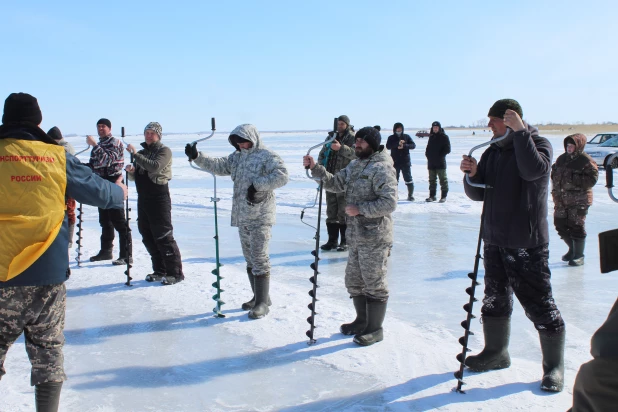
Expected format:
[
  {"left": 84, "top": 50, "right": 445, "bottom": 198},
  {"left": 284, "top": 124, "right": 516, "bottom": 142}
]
[{"left": 317, "top": 128, "right": 356, "bottom": 225}]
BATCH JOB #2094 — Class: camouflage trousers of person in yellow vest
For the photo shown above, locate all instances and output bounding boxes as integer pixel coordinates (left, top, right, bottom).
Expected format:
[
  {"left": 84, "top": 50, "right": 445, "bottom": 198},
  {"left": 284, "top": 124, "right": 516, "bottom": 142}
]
[{"left": 0, "top": 283, "right": 66, "bottom": 386}]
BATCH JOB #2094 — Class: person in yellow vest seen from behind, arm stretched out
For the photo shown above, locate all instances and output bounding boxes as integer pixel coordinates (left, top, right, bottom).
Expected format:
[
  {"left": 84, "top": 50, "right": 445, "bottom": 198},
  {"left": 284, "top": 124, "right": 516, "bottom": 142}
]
[{"left": 0, "top": 93, "right": 127, "bottom": 412}]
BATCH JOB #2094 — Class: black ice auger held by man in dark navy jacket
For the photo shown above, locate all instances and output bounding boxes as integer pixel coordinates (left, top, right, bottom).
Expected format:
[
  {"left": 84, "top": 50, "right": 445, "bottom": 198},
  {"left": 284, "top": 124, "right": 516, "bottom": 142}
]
[{"left": 455, "top": 129, "right": 510, "bottom": 393}]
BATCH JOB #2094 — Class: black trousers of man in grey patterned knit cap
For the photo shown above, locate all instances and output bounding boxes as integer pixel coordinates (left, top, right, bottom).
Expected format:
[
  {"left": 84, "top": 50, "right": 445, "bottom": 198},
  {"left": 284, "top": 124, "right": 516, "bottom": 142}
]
[{"left": 137, "top": 193, "right": 184, "bottom": 279}]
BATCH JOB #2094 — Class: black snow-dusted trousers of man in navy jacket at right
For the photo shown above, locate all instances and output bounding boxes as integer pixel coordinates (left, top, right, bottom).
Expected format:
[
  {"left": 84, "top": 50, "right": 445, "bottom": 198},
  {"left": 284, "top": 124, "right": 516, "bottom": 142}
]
[{"left": 481, "top": 244, "right": 564, "bottom": 332}]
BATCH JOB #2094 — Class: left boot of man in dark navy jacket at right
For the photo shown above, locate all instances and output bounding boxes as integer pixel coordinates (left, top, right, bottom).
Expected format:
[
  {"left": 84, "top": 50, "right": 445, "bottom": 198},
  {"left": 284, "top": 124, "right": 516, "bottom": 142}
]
[{"left": 466, "top": 316, "right": 511, "bottom": 372}]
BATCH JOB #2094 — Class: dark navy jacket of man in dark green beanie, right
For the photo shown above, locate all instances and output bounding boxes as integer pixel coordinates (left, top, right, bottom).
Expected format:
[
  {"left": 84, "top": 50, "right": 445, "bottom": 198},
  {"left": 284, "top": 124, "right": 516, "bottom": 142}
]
[{"left": 464, "top": 125, "right": 553, "bottom": 249}]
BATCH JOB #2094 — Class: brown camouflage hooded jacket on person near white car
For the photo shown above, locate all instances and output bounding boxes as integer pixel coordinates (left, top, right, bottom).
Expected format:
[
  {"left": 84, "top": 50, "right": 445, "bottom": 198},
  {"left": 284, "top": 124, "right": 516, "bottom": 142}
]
[{"left": 551, "top": 134, "right": 599, "bottom": 208}]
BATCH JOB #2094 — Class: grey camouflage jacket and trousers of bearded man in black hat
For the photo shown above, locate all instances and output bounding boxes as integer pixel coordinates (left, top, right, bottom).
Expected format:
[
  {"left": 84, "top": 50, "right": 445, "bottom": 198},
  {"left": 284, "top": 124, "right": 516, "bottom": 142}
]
[{"left": 312, "top": 147, "right": 397, "bottom": 301}]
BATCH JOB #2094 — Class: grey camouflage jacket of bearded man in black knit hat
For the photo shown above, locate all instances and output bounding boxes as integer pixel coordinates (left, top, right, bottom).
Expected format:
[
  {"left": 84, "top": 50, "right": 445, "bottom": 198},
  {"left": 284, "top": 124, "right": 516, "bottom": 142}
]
[{"left": 311, "top": 146, "right": 397, "bottom": 243}]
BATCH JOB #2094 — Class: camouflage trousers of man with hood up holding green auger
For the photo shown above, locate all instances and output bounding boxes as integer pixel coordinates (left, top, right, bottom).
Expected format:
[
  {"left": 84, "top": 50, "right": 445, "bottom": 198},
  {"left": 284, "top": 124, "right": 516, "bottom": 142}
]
[{"left": 238, "top": 225, "right": 272, "bottom": 276}]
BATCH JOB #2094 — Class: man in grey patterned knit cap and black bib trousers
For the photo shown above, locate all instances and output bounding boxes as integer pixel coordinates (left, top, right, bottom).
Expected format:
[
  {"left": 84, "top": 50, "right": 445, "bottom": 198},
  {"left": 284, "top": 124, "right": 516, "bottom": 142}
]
[{"left": 125, "top": 122, "right": 185, "bottom": 285}]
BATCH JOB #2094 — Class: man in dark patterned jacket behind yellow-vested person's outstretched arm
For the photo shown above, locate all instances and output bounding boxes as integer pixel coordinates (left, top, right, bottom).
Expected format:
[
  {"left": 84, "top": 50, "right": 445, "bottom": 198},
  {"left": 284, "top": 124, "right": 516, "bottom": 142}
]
[{"left": 86, "top": 119, "right": 133, "bottom": 265}]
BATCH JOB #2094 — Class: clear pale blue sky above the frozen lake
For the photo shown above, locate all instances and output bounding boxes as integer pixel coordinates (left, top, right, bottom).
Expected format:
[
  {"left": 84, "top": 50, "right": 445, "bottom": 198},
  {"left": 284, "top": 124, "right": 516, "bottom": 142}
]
[{"left": 0, "top": 0, "right": 618, "bottom": 134}]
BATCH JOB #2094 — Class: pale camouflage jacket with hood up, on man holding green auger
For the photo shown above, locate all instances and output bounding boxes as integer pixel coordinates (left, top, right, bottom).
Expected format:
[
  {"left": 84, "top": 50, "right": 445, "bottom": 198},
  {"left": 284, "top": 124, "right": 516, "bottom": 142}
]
[{"left": 195, "top": 124, "right": 288, "bottom": 226}]
